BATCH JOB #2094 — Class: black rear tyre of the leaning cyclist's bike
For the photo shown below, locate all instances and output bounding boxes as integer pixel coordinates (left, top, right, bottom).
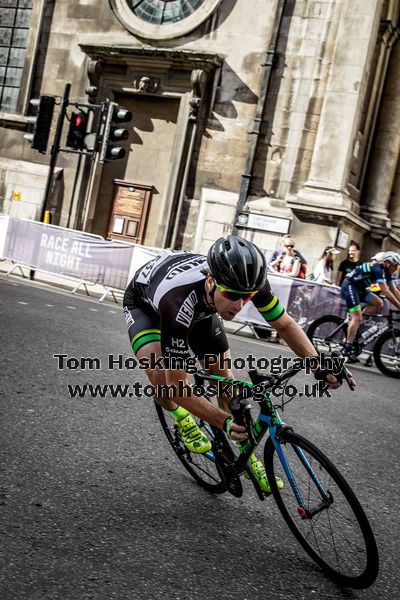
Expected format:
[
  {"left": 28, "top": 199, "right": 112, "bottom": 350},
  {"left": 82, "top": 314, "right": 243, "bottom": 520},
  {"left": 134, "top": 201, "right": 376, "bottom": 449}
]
[{"left": 154, "top": 402, "right": 243, "bottom": 497}]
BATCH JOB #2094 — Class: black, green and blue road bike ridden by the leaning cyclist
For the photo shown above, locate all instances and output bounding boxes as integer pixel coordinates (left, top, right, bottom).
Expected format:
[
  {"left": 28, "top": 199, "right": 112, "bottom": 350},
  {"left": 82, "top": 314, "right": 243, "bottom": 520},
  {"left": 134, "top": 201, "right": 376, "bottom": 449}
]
[{"left": 156, "top": 354, "right": 379, "bottom": 588}]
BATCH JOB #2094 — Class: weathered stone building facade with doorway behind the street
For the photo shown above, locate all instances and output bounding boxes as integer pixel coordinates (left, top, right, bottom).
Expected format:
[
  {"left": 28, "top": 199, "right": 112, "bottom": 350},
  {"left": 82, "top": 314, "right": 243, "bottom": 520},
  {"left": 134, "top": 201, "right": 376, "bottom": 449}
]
[{"left": 0, "top": 0, "right": 400, "bottom": 263}]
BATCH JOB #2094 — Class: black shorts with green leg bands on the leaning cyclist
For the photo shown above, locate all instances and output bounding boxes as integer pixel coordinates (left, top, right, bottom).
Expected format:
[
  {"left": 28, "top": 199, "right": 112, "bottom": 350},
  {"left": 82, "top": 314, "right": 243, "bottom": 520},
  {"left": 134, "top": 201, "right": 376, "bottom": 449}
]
[{"left": 124, "top": 293, "right": 229, "bottom": 359}]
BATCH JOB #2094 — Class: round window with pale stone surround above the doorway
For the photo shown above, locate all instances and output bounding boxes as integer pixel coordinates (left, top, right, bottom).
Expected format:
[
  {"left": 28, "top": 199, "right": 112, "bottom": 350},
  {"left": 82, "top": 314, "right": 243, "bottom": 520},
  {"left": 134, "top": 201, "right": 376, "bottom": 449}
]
[{"left": 110, "top": 0, "right": 221, "bottom": 40}]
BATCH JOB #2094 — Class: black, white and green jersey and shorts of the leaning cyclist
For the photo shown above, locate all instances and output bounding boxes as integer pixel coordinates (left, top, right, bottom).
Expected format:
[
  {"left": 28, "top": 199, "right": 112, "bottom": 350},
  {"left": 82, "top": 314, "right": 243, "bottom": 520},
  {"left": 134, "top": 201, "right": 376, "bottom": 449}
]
[{"left": 124, "top": 250, "right": 284, "bottom": 359}]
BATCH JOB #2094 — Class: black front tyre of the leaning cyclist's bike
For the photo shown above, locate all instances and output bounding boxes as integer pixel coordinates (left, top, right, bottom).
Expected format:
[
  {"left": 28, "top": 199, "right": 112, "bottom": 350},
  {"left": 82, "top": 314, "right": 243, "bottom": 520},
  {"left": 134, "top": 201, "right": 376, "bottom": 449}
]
[{"left": 264, "top": 431, "right": 379, "bottom": 589}]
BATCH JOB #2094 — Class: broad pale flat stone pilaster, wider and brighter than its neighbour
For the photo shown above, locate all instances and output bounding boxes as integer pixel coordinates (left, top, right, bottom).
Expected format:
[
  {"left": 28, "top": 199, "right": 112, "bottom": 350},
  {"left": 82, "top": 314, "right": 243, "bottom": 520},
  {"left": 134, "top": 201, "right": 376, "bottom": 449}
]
[{"left": 298, "top": 0, "right": 383, "bottom": 210}]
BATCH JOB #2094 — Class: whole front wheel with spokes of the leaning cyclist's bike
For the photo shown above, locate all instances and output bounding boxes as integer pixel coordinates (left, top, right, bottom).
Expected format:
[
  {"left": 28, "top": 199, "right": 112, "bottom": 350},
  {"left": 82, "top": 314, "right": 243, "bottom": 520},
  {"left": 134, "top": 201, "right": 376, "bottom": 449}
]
[{"left": 264, "top": 431, "right": 379, "bottom": 589}]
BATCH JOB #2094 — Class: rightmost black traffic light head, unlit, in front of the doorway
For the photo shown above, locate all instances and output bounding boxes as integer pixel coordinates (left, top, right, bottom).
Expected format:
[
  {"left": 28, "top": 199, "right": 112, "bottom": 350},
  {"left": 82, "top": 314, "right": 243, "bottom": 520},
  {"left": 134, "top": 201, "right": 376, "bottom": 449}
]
[{"left": 100, "top": 102, "right": 132, "bottom": 162}]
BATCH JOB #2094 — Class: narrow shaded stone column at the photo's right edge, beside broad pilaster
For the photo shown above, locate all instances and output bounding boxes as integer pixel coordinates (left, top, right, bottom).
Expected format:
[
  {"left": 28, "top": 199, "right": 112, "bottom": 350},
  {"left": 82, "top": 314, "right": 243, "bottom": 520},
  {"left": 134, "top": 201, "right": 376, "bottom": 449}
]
[{"left": 361, "top": 34, "right": 400, "bottom": 233}]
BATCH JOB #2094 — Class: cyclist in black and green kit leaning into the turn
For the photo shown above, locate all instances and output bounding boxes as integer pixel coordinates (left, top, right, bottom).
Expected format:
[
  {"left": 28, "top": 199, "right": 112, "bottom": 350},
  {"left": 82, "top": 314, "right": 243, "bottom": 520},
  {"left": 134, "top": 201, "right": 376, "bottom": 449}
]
[{"left": 124, "top": 236, "right": 346, "bottom": 492}]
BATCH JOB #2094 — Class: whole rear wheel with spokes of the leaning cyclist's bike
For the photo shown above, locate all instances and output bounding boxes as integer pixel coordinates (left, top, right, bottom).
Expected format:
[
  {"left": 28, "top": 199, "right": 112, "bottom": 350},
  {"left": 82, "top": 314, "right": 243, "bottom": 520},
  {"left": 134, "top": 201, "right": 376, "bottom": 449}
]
[{"left": 154, "top": 402, "right": 243, "bottom": 497}]
